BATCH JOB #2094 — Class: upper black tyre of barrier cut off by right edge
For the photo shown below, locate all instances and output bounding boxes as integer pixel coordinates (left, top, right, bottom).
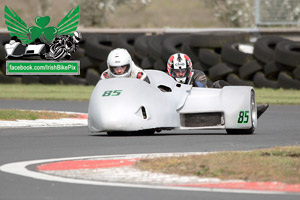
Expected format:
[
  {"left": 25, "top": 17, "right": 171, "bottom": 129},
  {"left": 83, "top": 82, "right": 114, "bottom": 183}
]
[{"left": 275, "top": 41, "right": 300, "bottom": 68}]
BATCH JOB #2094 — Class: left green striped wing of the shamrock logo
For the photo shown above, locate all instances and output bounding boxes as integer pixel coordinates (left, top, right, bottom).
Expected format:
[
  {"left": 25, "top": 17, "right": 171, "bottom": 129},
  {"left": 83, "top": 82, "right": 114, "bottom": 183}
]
[{"left": 4, "top": 5, "right": 32, "bottom": 44}]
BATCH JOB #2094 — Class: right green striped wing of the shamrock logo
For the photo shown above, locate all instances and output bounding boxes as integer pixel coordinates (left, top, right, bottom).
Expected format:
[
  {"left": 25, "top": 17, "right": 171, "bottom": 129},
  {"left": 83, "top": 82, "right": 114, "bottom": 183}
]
[{"left": 57, "top": 6, "right": 80, "bottom": 35}]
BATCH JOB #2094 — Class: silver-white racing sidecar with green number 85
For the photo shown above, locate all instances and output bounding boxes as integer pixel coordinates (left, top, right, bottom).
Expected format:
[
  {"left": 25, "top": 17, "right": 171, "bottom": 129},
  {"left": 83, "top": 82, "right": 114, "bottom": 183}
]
[{"left": 88, "top": 70, "right": 257, "bottom": 134}]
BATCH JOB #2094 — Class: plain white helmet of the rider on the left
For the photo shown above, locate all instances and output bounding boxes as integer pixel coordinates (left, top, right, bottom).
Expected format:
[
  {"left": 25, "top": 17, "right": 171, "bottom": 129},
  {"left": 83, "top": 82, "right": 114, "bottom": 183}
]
[{"left": 107, "top": 48, "right": 132, "bottom": 78}]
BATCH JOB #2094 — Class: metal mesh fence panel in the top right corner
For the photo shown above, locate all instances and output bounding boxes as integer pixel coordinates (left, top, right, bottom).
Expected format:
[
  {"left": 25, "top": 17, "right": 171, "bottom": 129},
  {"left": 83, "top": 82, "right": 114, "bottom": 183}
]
[{"left": 254, "top": 0, "right": 300, "bottom": 26}]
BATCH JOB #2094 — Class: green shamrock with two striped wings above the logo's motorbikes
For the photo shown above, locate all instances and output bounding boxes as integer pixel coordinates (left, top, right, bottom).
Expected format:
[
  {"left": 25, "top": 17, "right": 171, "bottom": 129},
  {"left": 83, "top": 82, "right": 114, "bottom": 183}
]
[{"left": 4, "top": 5, "right": 80, "bottom": 44}]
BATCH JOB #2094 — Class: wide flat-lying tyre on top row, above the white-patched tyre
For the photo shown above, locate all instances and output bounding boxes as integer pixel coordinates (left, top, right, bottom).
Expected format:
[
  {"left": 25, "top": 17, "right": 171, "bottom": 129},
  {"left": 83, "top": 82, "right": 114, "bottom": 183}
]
[{"left": 190, "top": 31, "right": 250, "bottom": 48}]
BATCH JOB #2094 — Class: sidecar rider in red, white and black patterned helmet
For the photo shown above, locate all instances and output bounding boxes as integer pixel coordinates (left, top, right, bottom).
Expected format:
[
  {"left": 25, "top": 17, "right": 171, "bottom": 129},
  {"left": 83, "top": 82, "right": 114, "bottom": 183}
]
[{"left": 167, "top": 53, "right": 269, "bottom": 118}]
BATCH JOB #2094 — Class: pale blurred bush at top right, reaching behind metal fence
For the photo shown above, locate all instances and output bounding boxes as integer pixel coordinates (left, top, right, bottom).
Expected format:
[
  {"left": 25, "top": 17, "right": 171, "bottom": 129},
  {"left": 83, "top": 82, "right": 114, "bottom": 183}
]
[{"left": 205, "top": 0, "right": 300, "bottom": 27}]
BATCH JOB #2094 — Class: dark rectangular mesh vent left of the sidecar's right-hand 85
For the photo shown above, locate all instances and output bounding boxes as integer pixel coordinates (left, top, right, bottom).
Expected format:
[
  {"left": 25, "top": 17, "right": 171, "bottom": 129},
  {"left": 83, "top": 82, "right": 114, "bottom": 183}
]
[{"left": 180, "top": 112, "right": 225, "bottom": 127}]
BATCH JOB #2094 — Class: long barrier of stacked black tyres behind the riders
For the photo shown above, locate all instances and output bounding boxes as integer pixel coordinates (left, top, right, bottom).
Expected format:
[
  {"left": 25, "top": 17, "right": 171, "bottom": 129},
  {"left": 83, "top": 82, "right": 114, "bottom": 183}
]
[{"left": 0, "top": 31, "right": 300, "bottom": 89}]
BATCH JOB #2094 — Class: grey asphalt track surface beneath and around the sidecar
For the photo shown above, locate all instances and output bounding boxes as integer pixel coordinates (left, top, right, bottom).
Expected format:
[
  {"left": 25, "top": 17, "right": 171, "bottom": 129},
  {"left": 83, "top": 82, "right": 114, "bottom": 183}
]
[{"left": 0, "top": 100, "right": 300, "bottom": 200}]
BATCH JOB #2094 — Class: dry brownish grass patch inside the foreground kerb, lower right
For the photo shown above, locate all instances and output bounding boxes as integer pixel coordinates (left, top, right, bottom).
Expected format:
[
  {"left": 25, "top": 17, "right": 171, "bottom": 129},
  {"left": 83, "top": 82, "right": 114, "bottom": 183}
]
[{"left": 135, "top": 146, "right": 300, "bottom": 184}]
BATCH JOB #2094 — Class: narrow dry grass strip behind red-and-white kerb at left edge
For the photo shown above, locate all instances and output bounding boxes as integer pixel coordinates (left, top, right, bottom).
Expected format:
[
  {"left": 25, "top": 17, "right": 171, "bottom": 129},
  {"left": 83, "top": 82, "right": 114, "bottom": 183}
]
[{"left": 0, "top": 109, "right": 77, "bottom": 121}]
